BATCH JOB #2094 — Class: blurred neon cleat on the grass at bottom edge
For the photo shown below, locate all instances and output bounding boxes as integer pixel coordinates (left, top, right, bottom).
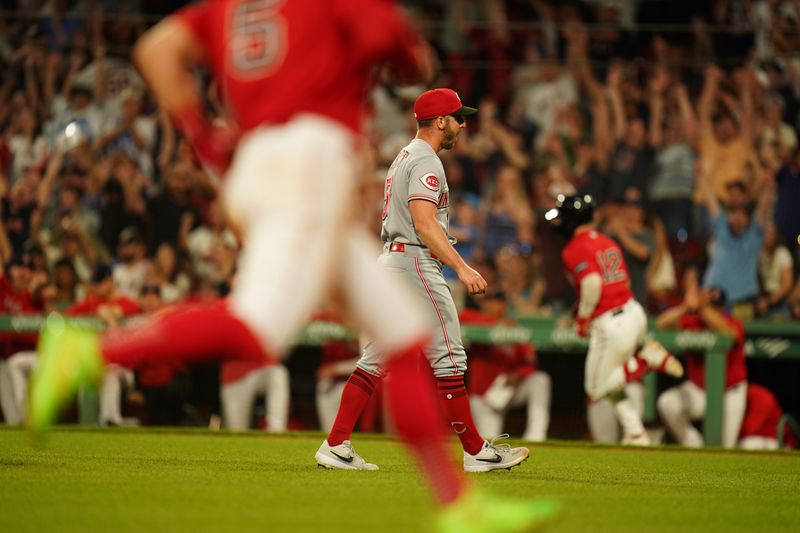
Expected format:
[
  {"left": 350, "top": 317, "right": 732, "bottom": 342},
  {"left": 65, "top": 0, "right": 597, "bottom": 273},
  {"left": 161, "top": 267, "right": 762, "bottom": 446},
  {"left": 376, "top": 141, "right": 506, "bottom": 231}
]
[{"left": 436, "top": 489, "right": 558, "bottom": 533}]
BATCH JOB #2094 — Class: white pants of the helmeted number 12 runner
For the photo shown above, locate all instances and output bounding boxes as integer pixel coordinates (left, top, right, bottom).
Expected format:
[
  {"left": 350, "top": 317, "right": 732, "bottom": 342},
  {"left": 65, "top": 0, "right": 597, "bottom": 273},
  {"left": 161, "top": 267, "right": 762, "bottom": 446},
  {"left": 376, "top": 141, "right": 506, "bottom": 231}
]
[{"left": 584, "top": 298, "right": 647, "bottom": 438}]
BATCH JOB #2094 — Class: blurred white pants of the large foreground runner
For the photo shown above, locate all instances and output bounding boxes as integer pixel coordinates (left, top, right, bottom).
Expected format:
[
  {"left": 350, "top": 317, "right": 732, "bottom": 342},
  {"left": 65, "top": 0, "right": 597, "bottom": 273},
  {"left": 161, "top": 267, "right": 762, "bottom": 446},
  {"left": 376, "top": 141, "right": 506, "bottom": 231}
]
[{"left": 224, "top": 114, "right": 428, "bottom": 356}]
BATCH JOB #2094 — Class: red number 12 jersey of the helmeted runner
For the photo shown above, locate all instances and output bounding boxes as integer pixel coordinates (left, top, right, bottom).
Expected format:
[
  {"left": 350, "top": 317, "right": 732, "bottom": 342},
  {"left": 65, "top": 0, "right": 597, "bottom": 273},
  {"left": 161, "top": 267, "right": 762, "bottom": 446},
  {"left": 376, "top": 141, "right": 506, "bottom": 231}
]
[{"left": 561, "top": 231, "right": 633, "bottom": 318}]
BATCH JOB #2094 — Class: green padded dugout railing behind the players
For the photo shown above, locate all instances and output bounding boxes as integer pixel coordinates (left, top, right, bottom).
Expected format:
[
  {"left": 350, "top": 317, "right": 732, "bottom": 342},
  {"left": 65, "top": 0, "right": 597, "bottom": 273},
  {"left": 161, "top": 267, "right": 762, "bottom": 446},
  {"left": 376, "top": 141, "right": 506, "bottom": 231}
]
[{"left": 0, "top": 315, "right": 800, "bottom": 446}]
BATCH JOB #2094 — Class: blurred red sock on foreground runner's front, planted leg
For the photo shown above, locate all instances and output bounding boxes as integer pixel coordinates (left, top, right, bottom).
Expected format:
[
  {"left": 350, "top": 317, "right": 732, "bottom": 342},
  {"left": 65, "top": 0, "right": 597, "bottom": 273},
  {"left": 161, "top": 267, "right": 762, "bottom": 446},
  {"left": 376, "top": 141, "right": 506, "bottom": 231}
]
[{"left": 386, "top": 345, "right": 467, "bottom": 505}]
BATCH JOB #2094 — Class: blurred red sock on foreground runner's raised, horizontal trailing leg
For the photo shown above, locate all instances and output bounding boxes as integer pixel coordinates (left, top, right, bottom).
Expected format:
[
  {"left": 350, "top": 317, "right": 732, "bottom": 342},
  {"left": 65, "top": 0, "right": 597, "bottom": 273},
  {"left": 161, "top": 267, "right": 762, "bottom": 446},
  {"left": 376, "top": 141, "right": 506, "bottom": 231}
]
[{"left": 101, "top": 300, "right": 266, "bottom": 369}]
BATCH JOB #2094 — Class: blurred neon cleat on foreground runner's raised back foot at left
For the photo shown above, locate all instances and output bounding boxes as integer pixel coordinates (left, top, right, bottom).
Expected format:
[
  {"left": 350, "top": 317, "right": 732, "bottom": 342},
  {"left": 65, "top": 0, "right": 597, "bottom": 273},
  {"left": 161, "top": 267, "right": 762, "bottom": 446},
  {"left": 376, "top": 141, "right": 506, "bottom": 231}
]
[{"left": 28, "top": 315, "right": 103, "bottom": 435}]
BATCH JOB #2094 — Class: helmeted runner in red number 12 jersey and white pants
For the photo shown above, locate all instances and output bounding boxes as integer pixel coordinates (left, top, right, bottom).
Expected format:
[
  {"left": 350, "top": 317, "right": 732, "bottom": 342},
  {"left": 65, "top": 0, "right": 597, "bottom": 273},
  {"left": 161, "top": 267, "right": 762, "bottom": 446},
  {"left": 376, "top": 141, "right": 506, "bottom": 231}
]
[{"left": 545, "top": 195, "right": 683, "bottom": 446}]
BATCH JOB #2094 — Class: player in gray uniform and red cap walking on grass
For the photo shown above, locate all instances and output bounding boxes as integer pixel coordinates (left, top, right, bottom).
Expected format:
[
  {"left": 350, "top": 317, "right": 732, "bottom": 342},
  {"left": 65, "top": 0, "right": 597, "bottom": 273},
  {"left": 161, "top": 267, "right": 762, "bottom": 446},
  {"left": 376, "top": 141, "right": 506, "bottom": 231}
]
[{"left": 316, "top": 89, "right": 529, "bottom": 472}]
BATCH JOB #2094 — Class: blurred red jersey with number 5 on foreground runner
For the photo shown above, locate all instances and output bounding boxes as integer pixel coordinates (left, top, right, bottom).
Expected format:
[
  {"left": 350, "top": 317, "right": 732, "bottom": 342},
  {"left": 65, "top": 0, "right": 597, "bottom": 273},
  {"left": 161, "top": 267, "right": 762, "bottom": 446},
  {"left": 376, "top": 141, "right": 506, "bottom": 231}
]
[{"left": 177, "top": 0, "right": 420, "bottom": 132}]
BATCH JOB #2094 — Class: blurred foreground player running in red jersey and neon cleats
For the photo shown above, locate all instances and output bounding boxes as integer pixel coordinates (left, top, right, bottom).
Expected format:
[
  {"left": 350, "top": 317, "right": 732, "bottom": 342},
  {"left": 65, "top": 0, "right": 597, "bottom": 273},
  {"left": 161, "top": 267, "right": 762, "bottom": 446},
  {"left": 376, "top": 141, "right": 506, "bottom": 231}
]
[{"left": 31, "top": 0, "right": 554, "bottom": 531}]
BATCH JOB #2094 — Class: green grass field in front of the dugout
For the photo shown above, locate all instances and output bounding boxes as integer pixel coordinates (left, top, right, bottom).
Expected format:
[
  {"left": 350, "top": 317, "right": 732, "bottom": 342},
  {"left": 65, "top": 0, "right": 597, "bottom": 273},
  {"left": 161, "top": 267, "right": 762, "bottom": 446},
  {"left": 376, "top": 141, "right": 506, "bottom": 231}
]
[{"left": 0, "top": 428, "right": 800, "bottom": 533}]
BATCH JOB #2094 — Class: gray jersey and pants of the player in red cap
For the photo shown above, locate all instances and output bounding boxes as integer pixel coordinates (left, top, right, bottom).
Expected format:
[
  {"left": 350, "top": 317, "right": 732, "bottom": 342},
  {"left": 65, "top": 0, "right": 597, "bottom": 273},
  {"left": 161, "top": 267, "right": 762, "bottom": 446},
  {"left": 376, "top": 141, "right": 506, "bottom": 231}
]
[{"left": 357, "top": 139, "right": 467, "bottom": 377}]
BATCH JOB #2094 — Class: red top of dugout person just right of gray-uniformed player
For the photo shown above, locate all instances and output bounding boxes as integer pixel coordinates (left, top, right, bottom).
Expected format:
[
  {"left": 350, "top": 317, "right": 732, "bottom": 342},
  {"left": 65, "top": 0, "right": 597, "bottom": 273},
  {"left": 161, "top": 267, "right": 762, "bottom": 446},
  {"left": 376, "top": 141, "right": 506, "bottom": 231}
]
[{"left": 459, "top": 309, "right": 537, "bottom": 396}]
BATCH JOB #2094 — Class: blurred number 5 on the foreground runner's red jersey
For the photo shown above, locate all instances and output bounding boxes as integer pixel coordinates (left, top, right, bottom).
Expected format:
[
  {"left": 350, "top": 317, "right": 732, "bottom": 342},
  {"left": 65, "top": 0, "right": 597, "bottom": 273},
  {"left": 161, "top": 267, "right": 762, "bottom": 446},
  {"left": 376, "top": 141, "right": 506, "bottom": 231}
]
[{"left": 228, "top": 0, "right": 286, "bottom": 79}]
